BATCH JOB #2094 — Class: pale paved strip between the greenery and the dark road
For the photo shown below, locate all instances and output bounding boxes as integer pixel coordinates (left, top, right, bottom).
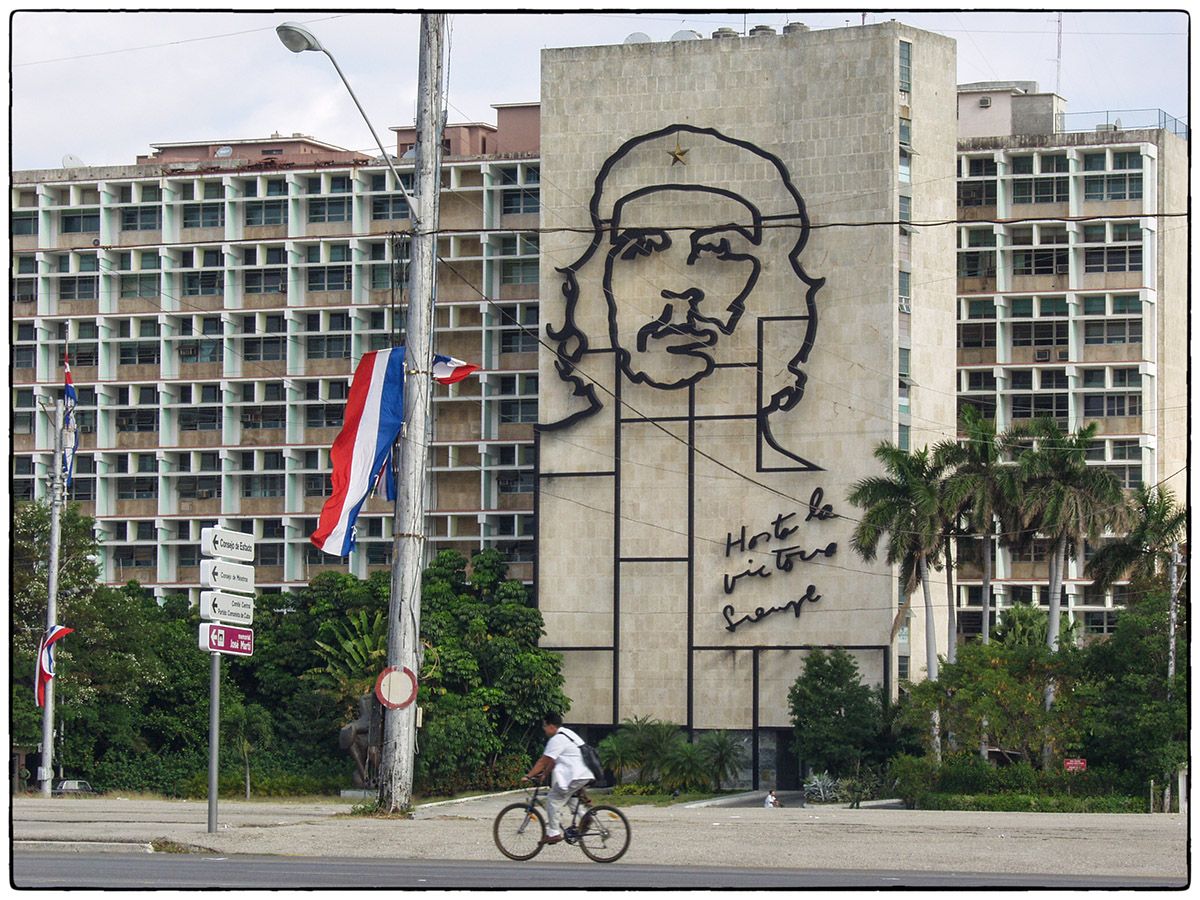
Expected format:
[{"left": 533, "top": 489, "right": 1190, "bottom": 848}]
[{"left": 12, "top": 794, "right": 1188, "bottom": 886}]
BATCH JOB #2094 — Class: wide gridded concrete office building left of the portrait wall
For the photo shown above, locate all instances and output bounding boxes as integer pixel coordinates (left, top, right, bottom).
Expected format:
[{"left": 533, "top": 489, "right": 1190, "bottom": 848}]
[{"left": 11, "top": 104, "right": 539, "bottom": 594}]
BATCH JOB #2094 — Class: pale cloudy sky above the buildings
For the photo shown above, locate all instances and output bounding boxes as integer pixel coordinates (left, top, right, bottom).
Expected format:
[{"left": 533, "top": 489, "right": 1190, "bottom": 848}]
[{"left": 8, "top": 5, "right": 1190, "bottom": 169}]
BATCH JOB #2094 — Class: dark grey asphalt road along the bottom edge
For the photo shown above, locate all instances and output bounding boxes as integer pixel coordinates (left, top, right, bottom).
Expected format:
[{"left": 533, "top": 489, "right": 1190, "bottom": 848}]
[{"left": 12, "top": 851, "right": 1178, "bottom": 890}]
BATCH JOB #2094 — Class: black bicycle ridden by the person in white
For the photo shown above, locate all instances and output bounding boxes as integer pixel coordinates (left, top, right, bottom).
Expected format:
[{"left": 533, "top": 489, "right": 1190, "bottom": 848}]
[{"left": 492, "top": 785, "right": 630, "bottom": 863}]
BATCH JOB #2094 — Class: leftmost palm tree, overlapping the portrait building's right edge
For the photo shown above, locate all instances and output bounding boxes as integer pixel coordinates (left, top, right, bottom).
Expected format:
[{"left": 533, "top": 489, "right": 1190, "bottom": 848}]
[{"left": 847, "top": 440, "right": 943, "bottom": 761}]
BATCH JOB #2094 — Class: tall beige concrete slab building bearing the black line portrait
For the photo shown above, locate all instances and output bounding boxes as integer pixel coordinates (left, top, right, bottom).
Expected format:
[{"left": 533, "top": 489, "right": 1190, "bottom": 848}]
[{"left": 536, "top": 23, "right": 955, "bottom": 785}]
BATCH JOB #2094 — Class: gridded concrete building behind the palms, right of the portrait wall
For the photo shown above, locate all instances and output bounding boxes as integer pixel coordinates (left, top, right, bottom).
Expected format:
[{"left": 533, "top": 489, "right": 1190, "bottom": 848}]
[{"left": 958, "top": 82, "right": 1188, "bottom": 635}]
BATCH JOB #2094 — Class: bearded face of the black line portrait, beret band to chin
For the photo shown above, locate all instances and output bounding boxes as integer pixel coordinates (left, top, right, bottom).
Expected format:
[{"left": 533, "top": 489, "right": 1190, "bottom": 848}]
[{"left": 604, "top": 186, "right": 762, "bottom": 390}]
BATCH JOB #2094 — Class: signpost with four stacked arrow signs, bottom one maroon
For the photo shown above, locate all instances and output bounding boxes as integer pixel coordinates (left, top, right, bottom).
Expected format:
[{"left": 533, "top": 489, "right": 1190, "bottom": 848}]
[{"left": 199, "top": 527, "right": 254, "bottom": 834}]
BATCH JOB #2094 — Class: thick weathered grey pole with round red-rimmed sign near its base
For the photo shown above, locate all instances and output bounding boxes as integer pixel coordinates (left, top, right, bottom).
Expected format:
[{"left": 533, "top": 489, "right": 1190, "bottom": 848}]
[{"left": 379, "top": 13, "right": 445, "bottom": 812}]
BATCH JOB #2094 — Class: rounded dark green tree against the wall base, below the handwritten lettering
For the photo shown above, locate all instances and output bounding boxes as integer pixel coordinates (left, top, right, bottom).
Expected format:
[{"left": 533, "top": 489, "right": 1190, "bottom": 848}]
[{"left": 787, "top": 647, "right": 880, "bottom": 775}]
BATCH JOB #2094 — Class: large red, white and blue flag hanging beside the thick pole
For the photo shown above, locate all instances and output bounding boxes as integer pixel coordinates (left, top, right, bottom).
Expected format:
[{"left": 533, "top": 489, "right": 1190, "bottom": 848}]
[{"left": 310, "top": 347, "right": 404, "bottom": 557}]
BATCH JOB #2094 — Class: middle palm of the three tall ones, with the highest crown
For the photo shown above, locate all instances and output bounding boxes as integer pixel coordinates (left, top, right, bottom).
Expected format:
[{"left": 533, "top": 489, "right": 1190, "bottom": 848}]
[{"left": 942, "top": 403, "right": 1020, "bottom": 643}]
